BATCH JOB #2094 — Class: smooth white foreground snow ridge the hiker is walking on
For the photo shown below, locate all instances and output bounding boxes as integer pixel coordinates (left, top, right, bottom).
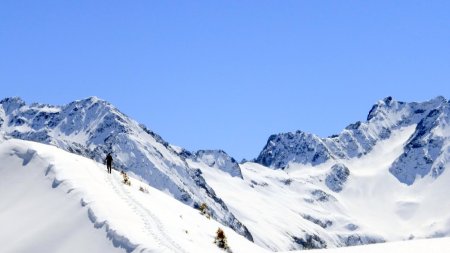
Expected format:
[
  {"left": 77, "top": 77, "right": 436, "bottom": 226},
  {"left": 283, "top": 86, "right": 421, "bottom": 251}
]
[{"left": 0, "top": 139, "right": 266, "bottom": 252}]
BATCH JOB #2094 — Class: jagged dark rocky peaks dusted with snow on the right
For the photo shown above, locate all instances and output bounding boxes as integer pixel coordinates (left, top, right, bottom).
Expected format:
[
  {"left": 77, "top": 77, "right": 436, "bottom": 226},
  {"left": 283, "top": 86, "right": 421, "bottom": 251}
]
[{"left": 255, "top": 97, "right": 449, "bottom": 184}]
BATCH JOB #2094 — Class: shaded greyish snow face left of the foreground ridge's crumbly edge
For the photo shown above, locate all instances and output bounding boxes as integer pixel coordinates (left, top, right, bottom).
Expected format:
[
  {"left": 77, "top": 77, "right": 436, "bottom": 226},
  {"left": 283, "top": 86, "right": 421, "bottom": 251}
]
[{"left": 0, "top": 145, "right": 123, "bottom": 253}]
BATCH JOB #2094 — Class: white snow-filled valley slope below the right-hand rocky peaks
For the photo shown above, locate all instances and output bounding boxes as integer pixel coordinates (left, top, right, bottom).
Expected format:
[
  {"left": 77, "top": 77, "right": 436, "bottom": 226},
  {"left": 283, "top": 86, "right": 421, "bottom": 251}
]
[{"left": 193, "top": 125, "right": 450, "bottom": 251}]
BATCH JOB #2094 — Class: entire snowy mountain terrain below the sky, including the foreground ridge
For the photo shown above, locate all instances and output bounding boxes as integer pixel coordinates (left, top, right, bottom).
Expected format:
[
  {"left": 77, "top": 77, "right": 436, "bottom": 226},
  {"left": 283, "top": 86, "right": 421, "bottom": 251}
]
[{"left": 0, "top": 97, "right": 450, "bottom": 253}]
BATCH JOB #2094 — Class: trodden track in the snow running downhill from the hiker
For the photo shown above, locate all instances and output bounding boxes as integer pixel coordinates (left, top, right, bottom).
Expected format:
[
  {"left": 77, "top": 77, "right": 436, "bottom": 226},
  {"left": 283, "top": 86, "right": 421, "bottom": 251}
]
[{"left": 105, "top": 172, "right": 187, "bottom": 253}]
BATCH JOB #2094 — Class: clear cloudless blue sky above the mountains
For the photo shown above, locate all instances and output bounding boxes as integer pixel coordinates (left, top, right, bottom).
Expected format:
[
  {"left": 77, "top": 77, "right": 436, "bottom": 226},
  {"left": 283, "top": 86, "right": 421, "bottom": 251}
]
[{"left": 0, "top": 0, "right": 450, "bottom": 159}]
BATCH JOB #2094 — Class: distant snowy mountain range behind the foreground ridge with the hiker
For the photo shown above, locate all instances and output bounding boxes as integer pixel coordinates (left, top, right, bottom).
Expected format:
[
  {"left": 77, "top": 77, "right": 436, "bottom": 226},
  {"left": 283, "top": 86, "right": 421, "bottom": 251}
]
[{"left": 0, "top": 97, "right": 450, "bottom": 252}]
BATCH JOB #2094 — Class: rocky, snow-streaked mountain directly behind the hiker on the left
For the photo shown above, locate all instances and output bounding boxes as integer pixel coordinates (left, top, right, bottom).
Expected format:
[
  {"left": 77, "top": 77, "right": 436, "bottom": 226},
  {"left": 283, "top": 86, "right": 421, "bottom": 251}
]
[{"left": 0, "top": 97, "right": 252, "bottom": 240}]
